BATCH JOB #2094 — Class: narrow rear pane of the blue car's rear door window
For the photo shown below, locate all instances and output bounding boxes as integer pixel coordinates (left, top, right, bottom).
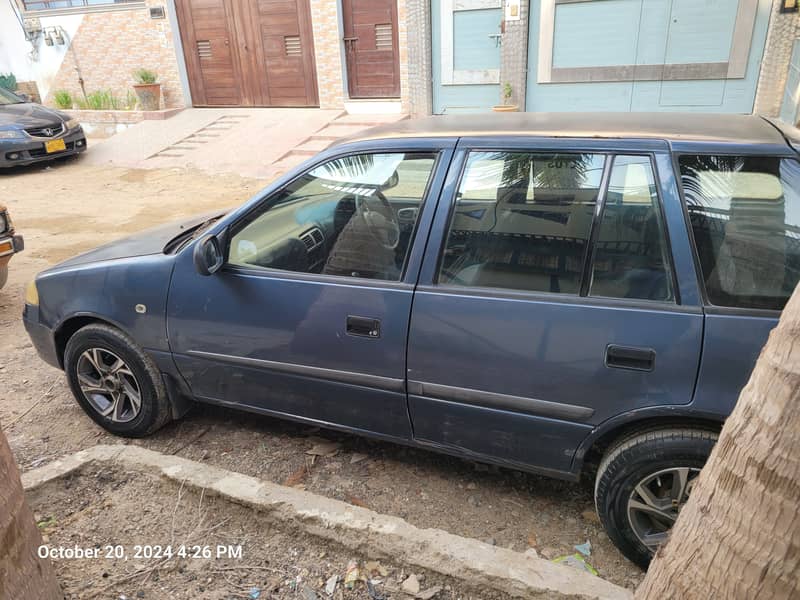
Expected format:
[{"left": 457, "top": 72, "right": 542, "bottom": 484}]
[{"left": 589, "top": 156, "right": 673, "bottom": 301}]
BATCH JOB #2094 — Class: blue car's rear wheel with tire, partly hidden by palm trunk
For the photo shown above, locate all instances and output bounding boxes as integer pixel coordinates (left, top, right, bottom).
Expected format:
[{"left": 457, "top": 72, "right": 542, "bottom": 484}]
[{"left": 594, "top": 428, "right": 718, "bottom": 569}]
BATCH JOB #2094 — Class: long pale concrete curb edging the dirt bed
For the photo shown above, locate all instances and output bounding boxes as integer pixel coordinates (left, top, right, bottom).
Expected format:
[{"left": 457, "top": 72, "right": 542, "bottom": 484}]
[{"left": 22, "top": 445, "right": 633, "bottom": 600}]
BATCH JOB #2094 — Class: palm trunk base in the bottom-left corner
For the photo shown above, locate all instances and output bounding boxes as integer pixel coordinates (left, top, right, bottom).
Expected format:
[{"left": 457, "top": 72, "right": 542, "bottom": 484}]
[{"left": 0, "top": 422, "right": 64, "bottom": 600}]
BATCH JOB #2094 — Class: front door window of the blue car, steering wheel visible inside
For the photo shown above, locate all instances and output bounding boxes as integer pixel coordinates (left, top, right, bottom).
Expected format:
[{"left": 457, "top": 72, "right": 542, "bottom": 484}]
[{"left": 228, "top": 152, "right": 436, "bottom": 281}]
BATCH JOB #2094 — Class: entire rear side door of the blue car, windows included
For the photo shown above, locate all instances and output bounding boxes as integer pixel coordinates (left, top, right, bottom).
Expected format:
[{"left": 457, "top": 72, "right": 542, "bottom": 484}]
[{"left": 408, "top": 139, "right": 703, "bottom": 476}]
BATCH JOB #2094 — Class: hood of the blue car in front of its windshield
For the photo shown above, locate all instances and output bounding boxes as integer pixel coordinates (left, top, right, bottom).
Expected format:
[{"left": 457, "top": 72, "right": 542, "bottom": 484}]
[{"left": 48, "top": 211, "right": 222, "bottom": 269}]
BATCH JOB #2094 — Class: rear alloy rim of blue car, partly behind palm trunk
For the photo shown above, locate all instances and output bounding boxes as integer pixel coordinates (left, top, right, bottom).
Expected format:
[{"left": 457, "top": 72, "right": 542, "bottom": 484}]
[{"left": 628, "top": 467, "right": 700, "bottom": 551}]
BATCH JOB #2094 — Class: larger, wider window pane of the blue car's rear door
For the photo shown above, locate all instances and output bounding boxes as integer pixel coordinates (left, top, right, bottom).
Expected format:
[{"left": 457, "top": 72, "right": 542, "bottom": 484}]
[{"left": 439, "top": 152, "right": 605, "bottom": 294}]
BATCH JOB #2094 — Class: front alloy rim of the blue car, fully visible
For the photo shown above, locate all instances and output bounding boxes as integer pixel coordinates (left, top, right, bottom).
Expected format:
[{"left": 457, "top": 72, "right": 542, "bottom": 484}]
[{"left": 76, "top": 348, "right": 142, "bottom": 423}]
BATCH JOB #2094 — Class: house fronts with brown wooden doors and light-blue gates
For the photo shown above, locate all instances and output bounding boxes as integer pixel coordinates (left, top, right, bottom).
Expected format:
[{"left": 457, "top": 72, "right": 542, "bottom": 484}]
[{"left": 0, "top": 0, "right": 800, "bottom": 121}]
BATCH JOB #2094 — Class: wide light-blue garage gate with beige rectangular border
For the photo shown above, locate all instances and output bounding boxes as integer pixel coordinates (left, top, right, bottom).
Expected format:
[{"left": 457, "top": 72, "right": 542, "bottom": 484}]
[{"left": 526, "top": 0, "right": 771, "bottom": 113}]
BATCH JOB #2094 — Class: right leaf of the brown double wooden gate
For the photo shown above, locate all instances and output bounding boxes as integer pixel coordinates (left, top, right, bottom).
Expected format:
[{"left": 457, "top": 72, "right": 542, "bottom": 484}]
[{"left": 248, "top": 0, "right": 319, "bottom": 106}]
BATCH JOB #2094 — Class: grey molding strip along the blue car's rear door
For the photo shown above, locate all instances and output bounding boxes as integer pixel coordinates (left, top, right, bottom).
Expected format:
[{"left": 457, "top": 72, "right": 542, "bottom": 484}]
[{"left": 408, "top": 381, "right": 594, "bottom": 421}]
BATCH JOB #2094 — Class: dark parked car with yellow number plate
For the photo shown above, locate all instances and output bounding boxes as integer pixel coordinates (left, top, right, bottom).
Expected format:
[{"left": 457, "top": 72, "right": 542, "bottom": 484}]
[{"left": 0, "top": 88, "right": 86, "bottom": 168}]
